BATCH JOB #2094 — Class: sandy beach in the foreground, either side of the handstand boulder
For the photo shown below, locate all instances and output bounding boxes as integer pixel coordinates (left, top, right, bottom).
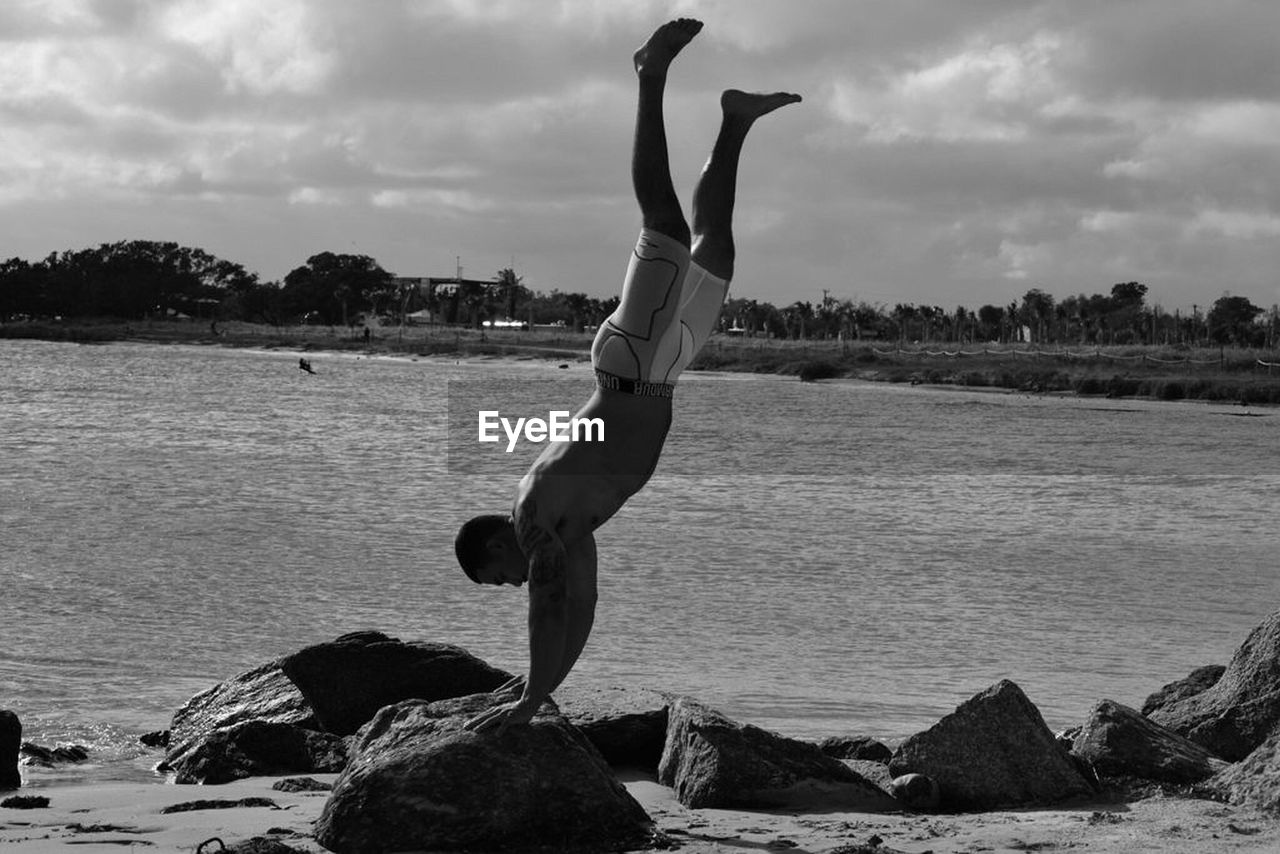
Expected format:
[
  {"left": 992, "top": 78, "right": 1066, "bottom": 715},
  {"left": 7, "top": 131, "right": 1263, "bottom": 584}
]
[{"left": 0, "top": 775, "right": 1280, "bottom": 854}]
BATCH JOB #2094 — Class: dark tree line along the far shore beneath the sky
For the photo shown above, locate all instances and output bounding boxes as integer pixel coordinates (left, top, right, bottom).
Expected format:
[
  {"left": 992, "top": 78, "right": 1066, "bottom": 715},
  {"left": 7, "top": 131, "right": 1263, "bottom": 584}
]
[{"left": 0, "top": 241, "right": 1280, "bottom": 348}]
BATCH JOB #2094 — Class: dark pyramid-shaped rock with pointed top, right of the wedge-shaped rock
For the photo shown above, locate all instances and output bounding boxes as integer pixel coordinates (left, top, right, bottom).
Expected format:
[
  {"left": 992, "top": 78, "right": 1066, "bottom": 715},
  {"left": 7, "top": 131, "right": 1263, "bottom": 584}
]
[{"left": 890, "top": 680, "right": 1093, "bottom": 809}]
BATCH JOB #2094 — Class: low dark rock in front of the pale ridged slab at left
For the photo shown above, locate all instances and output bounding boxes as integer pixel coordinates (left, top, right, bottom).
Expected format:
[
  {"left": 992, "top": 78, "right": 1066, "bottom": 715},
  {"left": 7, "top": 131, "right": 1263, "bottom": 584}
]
[{"left": 166, "top": 721, "right": 347, "bottom": 784}]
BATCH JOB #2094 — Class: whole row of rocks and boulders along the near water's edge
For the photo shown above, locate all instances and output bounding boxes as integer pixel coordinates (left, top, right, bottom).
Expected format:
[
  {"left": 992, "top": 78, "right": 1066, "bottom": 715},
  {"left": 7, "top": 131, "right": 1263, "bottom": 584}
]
[{"left": 0, "top": 611, "right": 1280, "bottom": 853}]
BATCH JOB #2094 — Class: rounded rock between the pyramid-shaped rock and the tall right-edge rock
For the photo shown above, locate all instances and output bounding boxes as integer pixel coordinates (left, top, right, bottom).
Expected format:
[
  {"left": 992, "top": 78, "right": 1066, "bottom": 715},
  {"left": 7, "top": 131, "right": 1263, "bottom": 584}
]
[{"left": 1071, "top": 700, "right": 1226, "bottom": 784}]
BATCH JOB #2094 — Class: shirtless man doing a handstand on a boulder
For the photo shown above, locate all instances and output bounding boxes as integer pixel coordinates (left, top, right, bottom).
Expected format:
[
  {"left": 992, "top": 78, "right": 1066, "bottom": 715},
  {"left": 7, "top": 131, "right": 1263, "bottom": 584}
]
[{"left": 454, "top": 18, "right": 800, "bottom": 731}]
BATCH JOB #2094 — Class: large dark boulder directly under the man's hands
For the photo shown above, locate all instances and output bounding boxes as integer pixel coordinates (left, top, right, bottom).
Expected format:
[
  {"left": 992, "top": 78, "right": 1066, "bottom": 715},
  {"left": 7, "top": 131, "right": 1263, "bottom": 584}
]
[{"left": 315, "top": 695, "right": 653, "bottom": 854}]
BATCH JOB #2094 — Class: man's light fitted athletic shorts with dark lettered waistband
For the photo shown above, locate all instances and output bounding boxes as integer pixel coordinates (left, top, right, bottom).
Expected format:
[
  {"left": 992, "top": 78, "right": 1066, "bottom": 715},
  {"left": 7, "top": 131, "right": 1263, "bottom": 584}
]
[{"left": 591, "top": 228, "right": 728, "bottom": 397}]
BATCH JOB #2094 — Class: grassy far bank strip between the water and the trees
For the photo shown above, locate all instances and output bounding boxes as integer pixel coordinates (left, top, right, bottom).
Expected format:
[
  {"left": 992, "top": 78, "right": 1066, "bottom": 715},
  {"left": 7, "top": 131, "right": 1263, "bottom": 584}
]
[{"left": 0, "top": 320, "right": 1280, "bottom": 406}]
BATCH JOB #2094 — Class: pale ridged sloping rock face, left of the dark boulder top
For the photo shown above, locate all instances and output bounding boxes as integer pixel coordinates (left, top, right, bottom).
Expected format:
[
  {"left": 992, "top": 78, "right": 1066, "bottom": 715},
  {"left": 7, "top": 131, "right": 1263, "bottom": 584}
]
[{"left": 169, "top": 661, "right": 317, "bottom": 755}]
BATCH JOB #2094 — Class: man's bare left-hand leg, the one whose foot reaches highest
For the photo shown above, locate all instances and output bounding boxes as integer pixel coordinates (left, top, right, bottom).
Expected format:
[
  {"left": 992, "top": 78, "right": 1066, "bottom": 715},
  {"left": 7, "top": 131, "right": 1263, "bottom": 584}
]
[{"left": 631, "top": 18, "right": 703, "bottom": 248}]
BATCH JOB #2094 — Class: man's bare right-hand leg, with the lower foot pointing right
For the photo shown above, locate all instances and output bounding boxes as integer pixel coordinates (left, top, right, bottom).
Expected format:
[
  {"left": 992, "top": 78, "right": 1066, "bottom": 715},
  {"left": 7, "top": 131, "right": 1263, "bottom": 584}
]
[{"left": 692, "top": 90, "right": 800, "bottom": 282}]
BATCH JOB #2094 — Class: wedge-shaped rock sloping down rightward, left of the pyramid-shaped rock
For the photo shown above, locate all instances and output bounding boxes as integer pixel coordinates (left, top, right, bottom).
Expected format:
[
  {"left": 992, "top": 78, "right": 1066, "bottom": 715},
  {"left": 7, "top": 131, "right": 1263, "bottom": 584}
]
[{"left": 658, "top": 698, "right": 893, "bottom": 810}]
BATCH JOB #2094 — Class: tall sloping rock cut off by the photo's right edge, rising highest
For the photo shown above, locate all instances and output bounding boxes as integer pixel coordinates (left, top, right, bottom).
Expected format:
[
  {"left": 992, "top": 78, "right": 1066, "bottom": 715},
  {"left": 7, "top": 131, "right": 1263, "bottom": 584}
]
[{"left": 1149, "top": 611, "right": 1280, "bottom": 762}]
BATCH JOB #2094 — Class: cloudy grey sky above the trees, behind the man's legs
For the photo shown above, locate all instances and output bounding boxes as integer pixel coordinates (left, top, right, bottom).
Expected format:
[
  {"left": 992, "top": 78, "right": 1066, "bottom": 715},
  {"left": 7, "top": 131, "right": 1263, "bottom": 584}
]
[{"left": 0, "top": 0, "right": 1280, "bottom": 310}]
